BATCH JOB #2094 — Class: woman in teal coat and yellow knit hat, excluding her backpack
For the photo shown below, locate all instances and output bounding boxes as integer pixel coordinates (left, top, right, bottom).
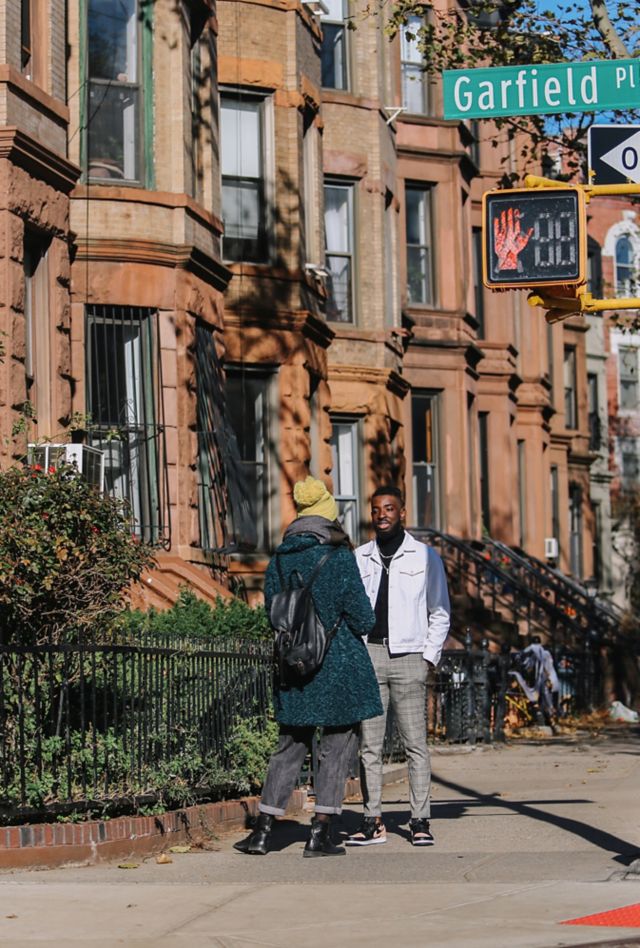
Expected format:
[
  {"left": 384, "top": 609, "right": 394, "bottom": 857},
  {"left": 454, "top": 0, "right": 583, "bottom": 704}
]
[{"left": 235, "top": 477, "right": 382, "bottom": 856}]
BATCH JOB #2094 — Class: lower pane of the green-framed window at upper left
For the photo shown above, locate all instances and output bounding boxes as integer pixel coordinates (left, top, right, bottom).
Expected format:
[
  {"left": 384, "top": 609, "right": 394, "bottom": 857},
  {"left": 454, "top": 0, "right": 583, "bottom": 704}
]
[{"left": 88, "top": 82, "right": 139, "bottom": 181}]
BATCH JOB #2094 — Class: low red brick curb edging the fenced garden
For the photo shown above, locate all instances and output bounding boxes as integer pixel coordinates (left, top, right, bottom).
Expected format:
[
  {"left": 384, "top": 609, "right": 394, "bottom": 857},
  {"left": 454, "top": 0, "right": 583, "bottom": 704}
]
[{"left": 0, "top": 789, "right": 307, "bottom": 869}]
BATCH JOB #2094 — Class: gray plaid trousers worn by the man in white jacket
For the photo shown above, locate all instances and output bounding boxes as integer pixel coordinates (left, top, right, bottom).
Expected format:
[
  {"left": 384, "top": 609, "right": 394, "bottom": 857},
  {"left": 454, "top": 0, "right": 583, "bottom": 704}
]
[{"left": 360, "top": 645, "right": 431, "bottom": 820}]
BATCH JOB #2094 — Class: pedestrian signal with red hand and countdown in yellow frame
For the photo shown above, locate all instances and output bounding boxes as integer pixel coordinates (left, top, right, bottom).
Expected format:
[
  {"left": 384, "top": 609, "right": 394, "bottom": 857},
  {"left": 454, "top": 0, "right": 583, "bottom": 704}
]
[{"left": 482, "top": 187, "right": 587, "bottom": 289}]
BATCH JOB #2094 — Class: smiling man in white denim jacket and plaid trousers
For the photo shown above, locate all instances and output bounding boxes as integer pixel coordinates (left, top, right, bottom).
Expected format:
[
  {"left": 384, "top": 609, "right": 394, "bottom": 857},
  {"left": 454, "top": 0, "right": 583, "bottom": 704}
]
[{"left": 347, "top": 486, "right": 451, "bottom": 846}]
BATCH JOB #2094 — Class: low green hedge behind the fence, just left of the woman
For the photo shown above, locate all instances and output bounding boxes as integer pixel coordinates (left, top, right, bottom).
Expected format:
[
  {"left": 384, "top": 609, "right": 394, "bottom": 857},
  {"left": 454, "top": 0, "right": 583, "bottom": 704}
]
[{"left": 118, "top": 587, "right": 273, "bottom": 642}]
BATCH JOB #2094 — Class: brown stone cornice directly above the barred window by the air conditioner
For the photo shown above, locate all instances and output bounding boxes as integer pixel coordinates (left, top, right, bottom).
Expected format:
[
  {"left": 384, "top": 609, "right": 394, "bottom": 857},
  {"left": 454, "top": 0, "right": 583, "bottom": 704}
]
[{"left": 76, "top": 238, "right": 231, "bottom": 291}]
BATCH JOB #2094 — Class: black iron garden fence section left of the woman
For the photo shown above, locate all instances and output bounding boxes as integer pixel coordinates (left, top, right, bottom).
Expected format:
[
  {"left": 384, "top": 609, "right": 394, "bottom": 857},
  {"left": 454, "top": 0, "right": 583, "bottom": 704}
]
[{"left": 0, "top": 639, "right": 272, "bottom": 820}]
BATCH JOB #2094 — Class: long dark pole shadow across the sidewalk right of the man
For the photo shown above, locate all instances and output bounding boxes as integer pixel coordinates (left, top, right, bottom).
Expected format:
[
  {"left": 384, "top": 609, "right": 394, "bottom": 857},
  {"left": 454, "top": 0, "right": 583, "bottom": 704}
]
[{"left": 433, "top": 774, "right": 640, "bottom": 866}]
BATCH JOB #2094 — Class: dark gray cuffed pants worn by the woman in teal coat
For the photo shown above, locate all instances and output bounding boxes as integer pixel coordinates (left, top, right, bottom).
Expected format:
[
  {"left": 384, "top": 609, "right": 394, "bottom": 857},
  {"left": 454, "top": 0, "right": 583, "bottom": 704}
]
[{"left": 258, "top": 725, "right": 358, "bottom": 816}]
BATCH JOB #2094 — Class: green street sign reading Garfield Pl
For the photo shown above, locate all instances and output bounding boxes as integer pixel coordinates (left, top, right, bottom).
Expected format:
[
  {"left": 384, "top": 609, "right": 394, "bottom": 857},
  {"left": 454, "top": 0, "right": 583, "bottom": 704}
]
[{"left": 443, "top": 59, "right": 640, "bottom": 119}]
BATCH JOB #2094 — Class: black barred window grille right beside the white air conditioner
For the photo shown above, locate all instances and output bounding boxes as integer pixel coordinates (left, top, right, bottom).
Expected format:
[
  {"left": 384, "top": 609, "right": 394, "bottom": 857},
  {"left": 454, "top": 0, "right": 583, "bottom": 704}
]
[{"left": 86, "top": 306, "right": 171, "bottom": 547}]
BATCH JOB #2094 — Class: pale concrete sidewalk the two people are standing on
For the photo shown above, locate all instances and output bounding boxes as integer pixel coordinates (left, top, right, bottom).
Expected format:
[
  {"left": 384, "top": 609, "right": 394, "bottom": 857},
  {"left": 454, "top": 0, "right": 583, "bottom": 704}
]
[{"left": 0, "top": 731, "right": 640, "bottom": 948}]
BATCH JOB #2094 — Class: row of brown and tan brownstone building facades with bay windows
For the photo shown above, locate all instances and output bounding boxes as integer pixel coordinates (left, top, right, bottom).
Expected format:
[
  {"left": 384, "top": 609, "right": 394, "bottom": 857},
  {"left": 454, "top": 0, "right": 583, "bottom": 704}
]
[{"left": 0, "top": 0, "right": 594, "bottom": 620}]
